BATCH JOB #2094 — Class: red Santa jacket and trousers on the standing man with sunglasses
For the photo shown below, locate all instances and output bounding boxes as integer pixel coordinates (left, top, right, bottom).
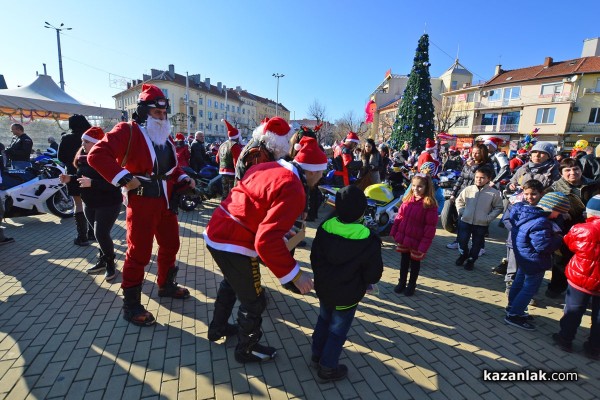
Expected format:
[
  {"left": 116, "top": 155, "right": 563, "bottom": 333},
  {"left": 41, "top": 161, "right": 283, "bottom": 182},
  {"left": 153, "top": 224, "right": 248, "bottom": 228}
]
[{"left": 88, "top": 122, "right": 187, "bottom": 289}]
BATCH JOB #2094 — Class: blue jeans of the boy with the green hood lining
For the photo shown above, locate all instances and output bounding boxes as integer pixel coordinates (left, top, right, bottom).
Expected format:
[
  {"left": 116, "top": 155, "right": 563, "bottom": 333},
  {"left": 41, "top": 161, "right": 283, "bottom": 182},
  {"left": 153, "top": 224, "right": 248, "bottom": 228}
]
[{"left": 312, "top": 304, "right": 356, "bottom": 368}]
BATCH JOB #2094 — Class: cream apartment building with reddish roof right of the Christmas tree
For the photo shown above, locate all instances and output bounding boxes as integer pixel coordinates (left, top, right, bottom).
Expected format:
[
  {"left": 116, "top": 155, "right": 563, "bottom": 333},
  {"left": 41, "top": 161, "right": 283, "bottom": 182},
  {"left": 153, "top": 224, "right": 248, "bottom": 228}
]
[{"left": 442, "top": 38, "right": 600, "bottom": 150}]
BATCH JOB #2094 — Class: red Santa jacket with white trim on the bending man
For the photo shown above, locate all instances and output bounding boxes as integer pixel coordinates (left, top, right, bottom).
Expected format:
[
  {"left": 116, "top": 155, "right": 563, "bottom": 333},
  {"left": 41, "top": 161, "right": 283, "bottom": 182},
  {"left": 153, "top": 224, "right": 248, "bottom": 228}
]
[{"left": 204, "top": 160, "right": 306, "bottom": 284}]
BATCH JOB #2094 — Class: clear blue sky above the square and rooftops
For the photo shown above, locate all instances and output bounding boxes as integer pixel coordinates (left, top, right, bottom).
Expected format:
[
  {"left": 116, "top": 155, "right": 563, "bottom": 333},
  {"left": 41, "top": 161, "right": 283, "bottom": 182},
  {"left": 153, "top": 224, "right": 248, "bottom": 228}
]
[{"left": 0, "top": 0, "right": 600, "bottom": 121}]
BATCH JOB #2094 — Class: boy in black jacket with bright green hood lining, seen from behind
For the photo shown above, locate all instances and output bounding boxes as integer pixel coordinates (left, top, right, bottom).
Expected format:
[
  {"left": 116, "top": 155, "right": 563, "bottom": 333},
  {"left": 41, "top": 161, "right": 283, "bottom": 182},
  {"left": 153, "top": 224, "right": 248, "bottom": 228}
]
[{"left": 310, "top": 185, "right": 383, "bottom": 383}]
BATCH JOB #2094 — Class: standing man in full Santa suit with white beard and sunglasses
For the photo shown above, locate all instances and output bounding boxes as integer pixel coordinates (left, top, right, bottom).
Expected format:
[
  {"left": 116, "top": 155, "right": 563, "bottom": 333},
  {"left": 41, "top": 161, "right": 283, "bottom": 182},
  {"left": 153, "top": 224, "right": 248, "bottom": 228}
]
[{"left": 88, "top": 84, "right": 194, "bottom": 326}]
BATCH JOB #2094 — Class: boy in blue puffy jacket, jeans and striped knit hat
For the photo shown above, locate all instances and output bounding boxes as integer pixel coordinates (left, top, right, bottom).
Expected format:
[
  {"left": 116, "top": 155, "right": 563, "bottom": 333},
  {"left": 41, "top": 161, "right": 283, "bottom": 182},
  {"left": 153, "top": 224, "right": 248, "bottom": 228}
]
[{"left": 504, "top": 192, "right": 570, "bottom": 331}]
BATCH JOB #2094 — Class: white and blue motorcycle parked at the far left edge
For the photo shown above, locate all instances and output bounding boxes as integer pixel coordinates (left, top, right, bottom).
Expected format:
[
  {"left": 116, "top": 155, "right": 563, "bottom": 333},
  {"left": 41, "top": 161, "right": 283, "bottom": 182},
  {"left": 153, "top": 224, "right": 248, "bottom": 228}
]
[{"left": 0, "top": 159, "right": 75, "bottom": 218}]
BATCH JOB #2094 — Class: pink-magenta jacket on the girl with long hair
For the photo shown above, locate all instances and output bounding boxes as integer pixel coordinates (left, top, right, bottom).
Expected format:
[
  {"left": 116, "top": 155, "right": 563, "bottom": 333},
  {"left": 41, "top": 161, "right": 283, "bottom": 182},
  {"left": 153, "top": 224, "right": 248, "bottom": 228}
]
[{"left": 390, "top": 198, "right": 438, "bottom": 253}]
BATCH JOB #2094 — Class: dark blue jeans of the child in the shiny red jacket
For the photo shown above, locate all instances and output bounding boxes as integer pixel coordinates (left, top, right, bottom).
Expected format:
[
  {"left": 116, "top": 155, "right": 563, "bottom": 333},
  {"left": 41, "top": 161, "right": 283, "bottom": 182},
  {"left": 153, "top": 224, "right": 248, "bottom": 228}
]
[{"left": 560, "top": 284, "right": 600, "bottom": 349}]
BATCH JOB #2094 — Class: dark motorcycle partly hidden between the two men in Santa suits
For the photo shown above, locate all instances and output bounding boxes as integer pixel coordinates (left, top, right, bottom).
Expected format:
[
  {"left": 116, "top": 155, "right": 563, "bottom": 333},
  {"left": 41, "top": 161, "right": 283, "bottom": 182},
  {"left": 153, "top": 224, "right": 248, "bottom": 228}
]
[{"left": 179, "top": 165, "right": 223, "bottom": 211}]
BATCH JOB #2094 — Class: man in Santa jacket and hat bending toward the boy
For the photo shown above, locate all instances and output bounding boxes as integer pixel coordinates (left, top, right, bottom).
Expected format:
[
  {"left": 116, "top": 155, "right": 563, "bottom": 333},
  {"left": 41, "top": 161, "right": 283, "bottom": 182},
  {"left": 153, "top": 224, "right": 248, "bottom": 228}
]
[{"left": 204, "top": 137, "right": 327, "bottom": 363}]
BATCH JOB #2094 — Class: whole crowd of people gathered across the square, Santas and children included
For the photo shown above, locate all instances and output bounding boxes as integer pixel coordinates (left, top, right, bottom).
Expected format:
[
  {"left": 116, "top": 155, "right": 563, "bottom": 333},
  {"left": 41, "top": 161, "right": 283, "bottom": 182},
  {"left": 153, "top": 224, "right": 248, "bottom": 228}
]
[{"left": 0, "top": 84, "right": 600, "bottom": 382}]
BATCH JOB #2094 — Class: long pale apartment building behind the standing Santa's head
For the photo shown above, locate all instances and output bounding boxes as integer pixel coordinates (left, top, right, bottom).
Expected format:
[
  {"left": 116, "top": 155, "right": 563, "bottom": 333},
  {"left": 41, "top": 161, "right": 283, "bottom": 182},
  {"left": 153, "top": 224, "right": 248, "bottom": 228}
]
[{"left": 113, "top": 64, "right": 290, "bottom": 142}]
